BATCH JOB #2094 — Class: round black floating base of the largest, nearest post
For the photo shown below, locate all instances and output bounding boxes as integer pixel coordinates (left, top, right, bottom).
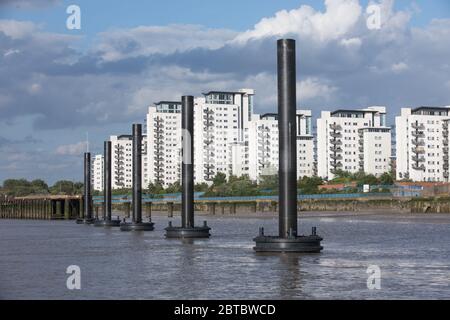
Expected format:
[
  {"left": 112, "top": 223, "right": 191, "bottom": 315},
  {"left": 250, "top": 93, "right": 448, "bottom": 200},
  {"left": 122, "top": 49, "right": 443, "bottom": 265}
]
[{"left": 253, "top": 235, "right": 323, "bottom": 253}]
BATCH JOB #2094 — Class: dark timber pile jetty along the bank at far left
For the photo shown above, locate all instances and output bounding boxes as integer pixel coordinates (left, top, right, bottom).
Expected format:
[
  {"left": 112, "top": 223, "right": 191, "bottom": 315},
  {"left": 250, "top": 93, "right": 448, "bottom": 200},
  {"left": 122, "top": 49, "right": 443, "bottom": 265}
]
[{"left": 0, "top": 199, "right": 83, "bottom": 220}]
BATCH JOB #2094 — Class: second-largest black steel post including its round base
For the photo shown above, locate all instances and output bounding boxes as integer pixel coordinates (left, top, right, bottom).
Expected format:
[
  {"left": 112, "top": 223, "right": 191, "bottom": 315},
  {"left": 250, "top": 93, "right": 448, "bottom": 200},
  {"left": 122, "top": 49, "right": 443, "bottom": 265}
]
[{"left": 166, "top": 96, "right": 211, "bottom": 238}]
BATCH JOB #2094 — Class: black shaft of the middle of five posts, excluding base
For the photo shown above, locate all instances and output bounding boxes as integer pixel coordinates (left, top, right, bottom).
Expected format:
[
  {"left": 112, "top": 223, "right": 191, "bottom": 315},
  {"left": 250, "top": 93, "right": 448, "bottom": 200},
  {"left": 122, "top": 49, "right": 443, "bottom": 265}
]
[{"left": 132, "top": 123, "right": 142, "bottom": 223}]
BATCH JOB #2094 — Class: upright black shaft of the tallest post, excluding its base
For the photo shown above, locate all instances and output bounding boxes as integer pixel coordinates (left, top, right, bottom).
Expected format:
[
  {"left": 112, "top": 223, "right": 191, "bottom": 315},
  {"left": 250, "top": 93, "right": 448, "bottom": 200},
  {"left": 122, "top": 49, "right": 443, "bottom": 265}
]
[{"left": 277, "top": 39, "right": 297, "bottom": 238}]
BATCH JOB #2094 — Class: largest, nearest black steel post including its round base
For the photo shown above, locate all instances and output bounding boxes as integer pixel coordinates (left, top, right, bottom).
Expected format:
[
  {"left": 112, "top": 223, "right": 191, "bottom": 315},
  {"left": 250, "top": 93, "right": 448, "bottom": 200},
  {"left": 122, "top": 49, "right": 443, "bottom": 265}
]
[{"left": 254, "top": 39, "right": 322, "bottom": 252}]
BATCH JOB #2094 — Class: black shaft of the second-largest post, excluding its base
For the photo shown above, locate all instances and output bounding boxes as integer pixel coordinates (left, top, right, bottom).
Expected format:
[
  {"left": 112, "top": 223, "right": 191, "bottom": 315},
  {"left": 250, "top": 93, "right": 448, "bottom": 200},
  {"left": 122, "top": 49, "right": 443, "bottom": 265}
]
[{"left": 181, "top": 96, "right": 194, "bottom": 228}]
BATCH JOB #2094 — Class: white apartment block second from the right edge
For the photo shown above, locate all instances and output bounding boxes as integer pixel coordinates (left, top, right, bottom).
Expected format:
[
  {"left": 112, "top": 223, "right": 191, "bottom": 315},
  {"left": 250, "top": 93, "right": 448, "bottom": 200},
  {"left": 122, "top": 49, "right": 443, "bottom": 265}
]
[{"left": 317, "top": 106, "right": 391, "bottom": 180}]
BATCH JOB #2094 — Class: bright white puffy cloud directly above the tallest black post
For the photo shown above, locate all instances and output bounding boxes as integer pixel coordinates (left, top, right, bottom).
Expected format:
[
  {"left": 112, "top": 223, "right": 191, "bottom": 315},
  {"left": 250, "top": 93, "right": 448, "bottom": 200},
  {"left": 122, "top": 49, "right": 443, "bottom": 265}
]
[{"left": 235, "top": 0, "right": 362, "bottom": 43}]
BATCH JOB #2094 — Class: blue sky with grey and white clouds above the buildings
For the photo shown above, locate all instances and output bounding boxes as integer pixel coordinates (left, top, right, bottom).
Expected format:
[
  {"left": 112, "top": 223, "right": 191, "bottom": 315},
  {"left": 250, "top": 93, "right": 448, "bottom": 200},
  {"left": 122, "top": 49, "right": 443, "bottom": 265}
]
[{"left": 0, "top": 0, "right": 450, "bottom": 183}]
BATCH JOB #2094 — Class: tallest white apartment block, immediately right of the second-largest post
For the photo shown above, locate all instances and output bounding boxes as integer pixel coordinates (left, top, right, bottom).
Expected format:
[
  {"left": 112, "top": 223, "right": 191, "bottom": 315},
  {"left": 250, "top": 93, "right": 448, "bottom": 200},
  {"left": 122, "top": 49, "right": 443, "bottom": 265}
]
[{"left": 194, "top": 89, "right": 254, "bottom": 183}]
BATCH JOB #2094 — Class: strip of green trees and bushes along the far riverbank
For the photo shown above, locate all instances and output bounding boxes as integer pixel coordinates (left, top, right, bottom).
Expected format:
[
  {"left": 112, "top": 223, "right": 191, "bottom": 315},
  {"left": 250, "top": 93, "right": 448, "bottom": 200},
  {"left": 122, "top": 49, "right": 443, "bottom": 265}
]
[{"left": 0, "top": 171, "right": 394, "bottom": 198}]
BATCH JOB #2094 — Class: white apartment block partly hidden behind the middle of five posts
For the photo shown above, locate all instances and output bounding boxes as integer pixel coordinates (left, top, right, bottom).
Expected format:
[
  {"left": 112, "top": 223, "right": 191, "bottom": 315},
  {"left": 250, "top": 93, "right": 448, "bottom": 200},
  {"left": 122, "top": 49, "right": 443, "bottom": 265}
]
[{"left": 110, "top": 135, "right": 150, "bottom": 189}]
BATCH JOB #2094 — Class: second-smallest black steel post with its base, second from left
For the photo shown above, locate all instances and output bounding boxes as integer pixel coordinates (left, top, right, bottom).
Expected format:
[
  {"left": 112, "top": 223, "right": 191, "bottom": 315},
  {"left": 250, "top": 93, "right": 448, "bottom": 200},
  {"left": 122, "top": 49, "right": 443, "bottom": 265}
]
[{"left": 94, "top": 141, "right": 120, "bottom": 227}]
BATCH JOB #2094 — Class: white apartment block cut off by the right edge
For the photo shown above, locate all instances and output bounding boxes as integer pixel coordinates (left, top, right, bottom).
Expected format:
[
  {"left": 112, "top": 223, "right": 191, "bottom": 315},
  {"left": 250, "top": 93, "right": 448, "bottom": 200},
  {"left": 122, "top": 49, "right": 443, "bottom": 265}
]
[{"left": 395, "top": 106, "right": 450, "bottom": 182}]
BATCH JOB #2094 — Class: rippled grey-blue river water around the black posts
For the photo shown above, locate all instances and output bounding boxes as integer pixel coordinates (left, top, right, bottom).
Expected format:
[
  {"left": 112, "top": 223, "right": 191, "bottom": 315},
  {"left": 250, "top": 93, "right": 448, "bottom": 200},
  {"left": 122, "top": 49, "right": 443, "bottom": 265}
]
[{"left": 0, "top": 213, "right": 450, "bottom": 299}]
